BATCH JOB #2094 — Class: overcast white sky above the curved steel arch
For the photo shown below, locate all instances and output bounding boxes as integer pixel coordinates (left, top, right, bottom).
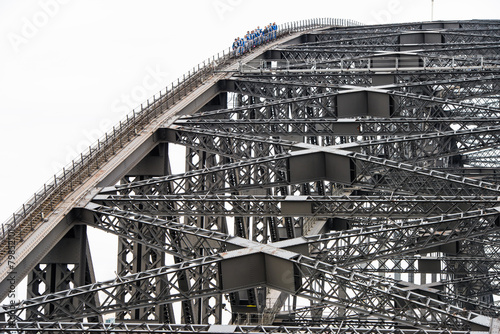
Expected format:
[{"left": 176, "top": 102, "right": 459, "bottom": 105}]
[{"left": 0, "top": 0, "right": 500, "bottom": 284}]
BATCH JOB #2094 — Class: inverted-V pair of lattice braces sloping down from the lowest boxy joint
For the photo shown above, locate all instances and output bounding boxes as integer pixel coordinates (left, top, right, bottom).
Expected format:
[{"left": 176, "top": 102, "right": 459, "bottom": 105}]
[{"left": 3, "top": 231, "right": 498, "bottom": 327}]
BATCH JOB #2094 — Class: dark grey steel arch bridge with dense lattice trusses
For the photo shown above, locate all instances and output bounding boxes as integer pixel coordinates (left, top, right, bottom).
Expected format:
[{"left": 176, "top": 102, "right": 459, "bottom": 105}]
[{"left": 0, "top": 19, "right": 500, "bottom": 334}]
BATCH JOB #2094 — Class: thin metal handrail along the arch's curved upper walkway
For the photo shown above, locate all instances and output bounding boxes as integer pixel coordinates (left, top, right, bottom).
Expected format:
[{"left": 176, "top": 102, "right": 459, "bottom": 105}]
[{"left": 0, "top": 18, "right": 361, "bottom": 254}]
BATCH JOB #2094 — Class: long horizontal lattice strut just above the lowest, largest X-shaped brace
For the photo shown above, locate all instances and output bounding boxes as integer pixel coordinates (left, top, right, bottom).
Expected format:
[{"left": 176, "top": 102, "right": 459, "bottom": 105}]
[{"left": 90, "top": 194, "right": 498, "bottom": 220}]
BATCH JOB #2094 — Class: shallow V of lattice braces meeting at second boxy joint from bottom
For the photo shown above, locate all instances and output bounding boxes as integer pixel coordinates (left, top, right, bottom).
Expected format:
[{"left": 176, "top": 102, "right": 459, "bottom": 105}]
[{"left": 170, "top": 119, "right": 500, "bottom": 163}]
